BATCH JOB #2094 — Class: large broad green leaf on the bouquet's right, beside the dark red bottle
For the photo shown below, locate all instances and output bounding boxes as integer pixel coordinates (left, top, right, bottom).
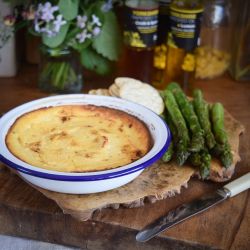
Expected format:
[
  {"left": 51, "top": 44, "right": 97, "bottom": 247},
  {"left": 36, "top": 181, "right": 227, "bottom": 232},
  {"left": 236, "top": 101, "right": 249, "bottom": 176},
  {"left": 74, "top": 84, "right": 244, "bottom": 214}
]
[{"left": 93, "top": 11, "right": 121, "bottom": 61}]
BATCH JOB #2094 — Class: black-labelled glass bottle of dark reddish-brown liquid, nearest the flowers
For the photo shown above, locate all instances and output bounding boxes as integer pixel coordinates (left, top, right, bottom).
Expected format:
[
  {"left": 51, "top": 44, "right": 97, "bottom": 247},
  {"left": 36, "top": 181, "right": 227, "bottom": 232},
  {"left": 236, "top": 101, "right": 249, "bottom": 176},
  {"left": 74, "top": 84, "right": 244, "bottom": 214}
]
[{"left": 119, "top": 0, "right": 159, "bottom": 83}]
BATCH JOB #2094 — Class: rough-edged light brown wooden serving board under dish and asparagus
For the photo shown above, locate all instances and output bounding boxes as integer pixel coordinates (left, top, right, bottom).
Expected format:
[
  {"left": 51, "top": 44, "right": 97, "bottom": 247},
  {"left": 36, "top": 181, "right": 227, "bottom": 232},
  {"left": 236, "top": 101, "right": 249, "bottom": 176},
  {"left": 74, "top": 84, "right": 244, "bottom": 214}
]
[{"left": 18, "top": 106, "right": 244, "bottom": 220}]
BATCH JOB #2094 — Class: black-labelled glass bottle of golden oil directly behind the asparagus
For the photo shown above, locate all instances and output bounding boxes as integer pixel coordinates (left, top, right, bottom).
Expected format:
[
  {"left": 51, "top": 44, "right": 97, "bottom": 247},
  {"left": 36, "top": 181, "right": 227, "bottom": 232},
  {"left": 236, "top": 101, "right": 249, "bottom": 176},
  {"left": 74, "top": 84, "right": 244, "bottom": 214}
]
[{"left": 159, "top": 0, "right": 203, "bottom": 91}]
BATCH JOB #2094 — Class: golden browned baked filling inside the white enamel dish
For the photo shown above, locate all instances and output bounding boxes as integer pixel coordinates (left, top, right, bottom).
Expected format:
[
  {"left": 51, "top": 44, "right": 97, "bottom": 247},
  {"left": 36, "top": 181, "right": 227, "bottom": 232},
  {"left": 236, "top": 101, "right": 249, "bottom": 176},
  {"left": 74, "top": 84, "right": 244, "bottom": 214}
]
[{"left": 6, "top": 105, "right": 151, "bottom": 172}]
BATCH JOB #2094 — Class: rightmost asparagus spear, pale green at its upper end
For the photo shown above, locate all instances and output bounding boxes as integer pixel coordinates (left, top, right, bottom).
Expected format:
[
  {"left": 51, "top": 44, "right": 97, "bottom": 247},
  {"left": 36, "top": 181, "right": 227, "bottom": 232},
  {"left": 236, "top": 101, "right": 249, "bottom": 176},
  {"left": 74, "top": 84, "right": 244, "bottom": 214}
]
[{"left": 211, "top": 103, "right": 233, "bottom": 168}]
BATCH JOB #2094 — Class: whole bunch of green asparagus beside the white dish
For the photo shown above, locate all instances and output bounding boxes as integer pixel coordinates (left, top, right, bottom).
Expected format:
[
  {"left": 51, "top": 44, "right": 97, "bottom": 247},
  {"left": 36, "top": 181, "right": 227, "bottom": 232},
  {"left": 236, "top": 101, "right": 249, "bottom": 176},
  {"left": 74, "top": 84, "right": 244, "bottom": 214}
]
[{"left": 161, "top": 82, "right": 233, "bottom": 179}]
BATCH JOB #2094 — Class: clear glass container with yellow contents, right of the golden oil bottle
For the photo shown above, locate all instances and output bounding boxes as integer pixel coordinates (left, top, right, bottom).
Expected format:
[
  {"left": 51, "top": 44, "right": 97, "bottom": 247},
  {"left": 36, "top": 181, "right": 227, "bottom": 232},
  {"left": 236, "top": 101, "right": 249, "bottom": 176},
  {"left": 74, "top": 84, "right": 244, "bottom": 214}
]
[{"left": 195, "top": 0, "right": 232, "bottom": 79}]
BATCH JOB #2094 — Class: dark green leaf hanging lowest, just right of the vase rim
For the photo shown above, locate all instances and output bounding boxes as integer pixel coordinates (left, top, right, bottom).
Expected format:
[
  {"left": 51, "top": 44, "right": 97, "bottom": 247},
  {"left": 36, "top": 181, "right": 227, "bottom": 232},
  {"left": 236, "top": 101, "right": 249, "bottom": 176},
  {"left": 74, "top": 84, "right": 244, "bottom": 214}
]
[{"left": 81, "top": 47, "right": 112, "bottom": 75}]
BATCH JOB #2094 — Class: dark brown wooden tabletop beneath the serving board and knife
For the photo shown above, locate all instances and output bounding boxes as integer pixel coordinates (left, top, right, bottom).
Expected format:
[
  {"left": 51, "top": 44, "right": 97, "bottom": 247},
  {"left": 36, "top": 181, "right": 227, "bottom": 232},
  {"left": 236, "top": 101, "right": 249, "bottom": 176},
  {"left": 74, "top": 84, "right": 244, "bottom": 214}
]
[{"left": 0, "top": 65, "right": 250, "bottom": 250}]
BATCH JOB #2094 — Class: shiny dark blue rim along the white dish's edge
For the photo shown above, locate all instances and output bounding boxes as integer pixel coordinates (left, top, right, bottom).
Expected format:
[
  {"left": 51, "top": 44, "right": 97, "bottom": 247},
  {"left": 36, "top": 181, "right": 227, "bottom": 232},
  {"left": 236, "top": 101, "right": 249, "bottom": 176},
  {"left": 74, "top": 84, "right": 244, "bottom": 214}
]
[{"left": 0, "top": 119, "right": 172, "bottom": 182}]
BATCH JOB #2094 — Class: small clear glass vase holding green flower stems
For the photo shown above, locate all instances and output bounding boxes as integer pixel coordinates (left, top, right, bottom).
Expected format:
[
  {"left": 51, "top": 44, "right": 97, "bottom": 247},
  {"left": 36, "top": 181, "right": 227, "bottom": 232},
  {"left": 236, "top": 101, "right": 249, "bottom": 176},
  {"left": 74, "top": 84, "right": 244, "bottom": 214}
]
[{"left": 38, "top": 47, "right": 83, "bottom": 94}]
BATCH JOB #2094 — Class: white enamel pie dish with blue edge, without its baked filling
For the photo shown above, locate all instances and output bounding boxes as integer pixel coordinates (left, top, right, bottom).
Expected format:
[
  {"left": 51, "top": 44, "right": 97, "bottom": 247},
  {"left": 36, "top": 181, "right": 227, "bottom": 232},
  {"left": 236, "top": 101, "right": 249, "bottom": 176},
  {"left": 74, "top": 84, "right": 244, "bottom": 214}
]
[{"left": 0, "top": 94, "right": 171, "bottom": 194}]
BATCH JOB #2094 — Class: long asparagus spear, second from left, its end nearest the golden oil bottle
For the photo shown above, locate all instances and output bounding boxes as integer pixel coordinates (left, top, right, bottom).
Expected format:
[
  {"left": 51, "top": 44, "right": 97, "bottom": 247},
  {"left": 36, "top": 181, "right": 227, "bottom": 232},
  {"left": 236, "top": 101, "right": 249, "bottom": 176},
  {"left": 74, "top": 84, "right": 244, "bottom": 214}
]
[{"left": 168, "top": 83, "right": 204, "bottom": 152}]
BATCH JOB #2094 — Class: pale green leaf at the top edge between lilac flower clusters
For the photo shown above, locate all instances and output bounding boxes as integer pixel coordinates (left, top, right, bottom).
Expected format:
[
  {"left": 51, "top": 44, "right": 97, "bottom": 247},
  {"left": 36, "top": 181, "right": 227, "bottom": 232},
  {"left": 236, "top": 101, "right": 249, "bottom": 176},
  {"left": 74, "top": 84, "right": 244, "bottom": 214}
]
[{"left": 58, "top": 0, "right": 79, "bottom": 21}]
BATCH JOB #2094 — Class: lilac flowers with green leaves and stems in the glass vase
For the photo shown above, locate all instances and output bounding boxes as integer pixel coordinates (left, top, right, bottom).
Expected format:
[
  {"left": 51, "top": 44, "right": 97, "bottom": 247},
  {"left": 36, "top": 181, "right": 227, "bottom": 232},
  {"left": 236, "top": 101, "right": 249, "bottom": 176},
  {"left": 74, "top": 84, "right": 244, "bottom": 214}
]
[{"left": 4, "top": 0, "right": 121, "bottom": 92}]
